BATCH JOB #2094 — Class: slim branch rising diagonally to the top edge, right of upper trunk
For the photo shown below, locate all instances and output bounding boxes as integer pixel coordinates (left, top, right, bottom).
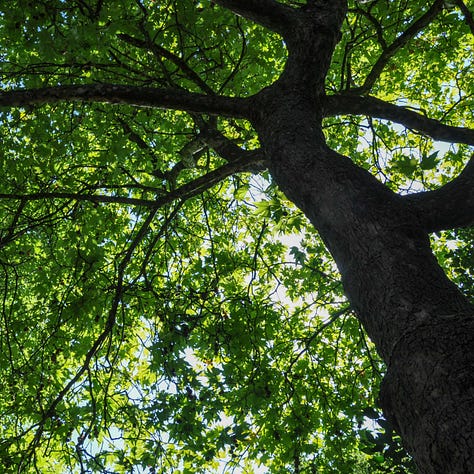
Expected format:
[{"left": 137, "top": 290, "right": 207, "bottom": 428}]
[{"left": 350, "top": 0, "right": 444, "bottom": 94}]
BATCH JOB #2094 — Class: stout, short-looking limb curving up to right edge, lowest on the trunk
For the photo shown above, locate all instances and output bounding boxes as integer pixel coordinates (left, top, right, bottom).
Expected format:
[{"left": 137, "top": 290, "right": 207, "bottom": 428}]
[{"left": 403, "top": 155, "right": 474, "bottom": 232}]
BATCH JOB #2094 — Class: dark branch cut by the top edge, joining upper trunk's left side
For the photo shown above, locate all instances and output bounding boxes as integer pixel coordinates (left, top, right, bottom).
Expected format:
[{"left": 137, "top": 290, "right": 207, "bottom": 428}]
[{"left": 214, "top": 0, "right": 294, "bottom": 35}]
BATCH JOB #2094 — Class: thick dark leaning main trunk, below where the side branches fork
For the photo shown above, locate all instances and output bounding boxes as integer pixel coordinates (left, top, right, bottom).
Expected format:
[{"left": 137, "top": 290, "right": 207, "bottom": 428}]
[{"left": 254, "top": 90, "right": 474, "bottom": 474}]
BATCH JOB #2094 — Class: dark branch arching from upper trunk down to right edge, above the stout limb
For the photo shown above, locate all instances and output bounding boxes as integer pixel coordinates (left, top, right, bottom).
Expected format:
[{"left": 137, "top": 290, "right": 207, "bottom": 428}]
[{"left": 323, "top": 94, "right": 474, "bottom": 145}]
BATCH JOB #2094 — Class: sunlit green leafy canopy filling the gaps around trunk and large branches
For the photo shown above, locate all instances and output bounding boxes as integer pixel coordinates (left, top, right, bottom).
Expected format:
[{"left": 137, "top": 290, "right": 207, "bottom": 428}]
[{"left": 0, "top": 0, "right": 474, "bottom": 473}]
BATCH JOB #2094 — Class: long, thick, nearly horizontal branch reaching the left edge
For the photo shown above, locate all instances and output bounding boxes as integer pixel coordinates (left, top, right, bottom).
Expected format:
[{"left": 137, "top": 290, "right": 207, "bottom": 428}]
[{"left": 0, "top": 84, "right": 249, "bottom": 118}]
